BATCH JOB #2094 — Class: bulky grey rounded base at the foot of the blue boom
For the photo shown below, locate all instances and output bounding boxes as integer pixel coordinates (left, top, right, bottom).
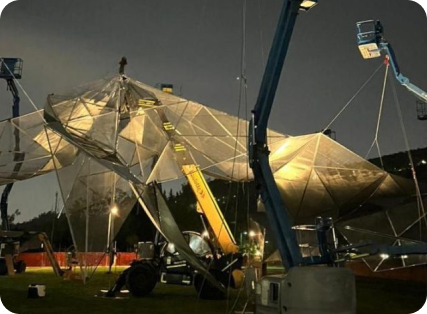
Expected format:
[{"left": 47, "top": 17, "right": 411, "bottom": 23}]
[{"left": 255, "top": 266, "right": 356, "bottom": 314}]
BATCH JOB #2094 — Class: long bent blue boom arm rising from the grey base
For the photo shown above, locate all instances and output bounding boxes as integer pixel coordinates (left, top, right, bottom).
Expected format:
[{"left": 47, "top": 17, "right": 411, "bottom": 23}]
[{"left": 248, "top": 0, "right": 317, "bottom": 269}]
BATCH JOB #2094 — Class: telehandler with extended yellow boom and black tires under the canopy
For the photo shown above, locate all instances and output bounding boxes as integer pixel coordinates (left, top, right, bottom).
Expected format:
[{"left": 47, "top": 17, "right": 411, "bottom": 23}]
[{"left": 107, "top": 84, "right": 244, "bottom": 299}]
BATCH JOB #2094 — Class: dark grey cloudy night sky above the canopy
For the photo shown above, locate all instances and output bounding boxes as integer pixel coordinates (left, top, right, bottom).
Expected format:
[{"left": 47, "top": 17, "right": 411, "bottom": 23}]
[{"left": 0, "top": 0, "right": 427, "bottom": 220}]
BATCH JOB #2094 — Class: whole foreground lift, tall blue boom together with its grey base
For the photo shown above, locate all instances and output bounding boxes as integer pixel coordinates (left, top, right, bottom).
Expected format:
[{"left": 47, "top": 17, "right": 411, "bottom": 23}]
[{"left": 248, "top": 0, "right": 427, "bottom": 314}]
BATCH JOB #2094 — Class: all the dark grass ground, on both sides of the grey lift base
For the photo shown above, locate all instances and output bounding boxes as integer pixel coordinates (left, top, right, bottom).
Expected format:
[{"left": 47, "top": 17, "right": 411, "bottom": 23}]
[{"left": 0, "top": 268, "right": 427, "bottom": 314}]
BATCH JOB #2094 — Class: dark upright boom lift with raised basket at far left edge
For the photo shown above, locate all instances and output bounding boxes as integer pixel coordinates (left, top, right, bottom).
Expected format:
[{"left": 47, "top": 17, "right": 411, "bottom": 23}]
[{"left": 0, "top": 58, "right": 25, "bottom": 231}]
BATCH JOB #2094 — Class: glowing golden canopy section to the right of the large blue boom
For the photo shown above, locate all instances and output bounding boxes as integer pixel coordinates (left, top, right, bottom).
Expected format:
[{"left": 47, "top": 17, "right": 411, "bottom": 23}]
[{"left": 270, "top": 133, "right": 415, "bottom": 224}]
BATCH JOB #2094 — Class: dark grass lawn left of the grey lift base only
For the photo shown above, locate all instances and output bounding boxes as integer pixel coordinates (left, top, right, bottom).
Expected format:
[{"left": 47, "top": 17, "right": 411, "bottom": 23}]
[{"left": 0, "top": 268, "right": 245, "bottom": 314}]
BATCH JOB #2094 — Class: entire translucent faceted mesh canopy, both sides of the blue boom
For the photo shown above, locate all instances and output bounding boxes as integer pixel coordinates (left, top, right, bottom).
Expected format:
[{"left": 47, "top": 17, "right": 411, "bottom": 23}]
[{"left": 0, "top": 75, "right": 427, "bottom": 269}]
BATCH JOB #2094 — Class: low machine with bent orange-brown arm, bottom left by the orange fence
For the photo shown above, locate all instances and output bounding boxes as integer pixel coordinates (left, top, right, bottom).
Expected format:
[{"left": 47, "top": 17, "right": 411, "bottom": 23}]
[{"left": 0, "top": 231, "right": 65, "bottom": 277}]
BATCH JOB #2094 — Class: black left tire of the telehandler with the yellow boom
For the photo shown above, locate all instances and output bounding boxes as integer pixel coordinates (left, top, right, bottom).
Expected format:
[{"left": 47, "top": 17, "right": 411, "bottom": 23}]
[{"left": 126, "top": 263, "right": 157, "bottom": 298}]
